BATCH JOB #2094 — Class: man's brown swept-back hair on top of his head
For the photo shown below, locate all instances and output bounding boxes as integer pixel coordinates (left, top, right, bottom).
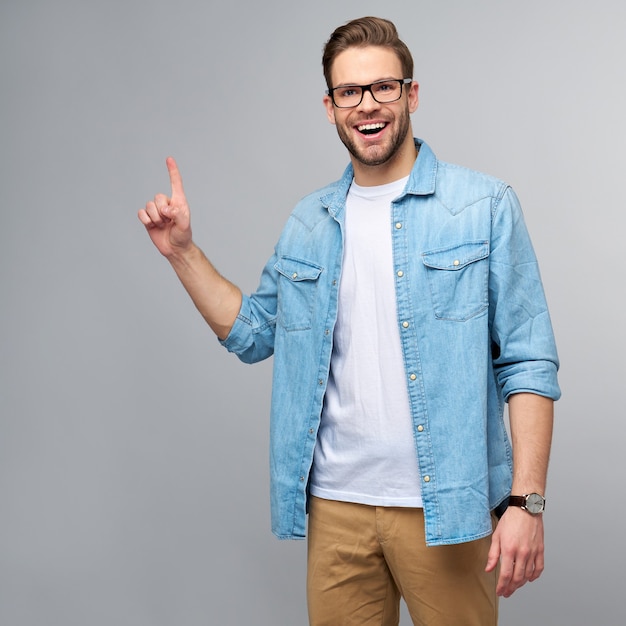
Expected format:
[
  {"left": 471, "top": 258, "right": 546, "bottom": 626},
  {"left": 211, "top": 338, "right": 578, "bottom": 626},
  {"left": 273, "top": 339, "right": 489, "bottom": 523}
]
[{"left": 322, "top": 17, "right": 413, "bottom": 89}]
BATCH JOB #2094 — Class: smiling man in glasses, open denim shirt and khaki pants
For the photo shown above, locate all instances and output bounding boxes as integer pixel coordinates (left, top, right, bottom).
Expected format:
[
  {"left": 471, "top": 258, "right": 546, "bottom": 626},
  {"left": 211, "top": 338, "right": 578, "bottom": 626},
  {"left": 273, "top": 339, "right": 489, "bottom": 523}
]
[{"left": 139, "top": 17, "right": 560, "bottom": 626}]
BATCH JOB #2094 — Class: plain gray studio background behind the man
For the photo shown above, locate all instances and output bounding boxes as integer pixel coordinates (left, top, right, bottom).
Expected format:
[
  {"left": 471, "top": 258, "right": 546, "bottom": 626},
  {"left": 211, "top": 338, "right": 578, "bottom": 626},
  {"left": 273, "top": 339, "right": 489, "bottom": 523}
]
[{"left": 0, "top": 0, "right": 626, "bottom": 626}]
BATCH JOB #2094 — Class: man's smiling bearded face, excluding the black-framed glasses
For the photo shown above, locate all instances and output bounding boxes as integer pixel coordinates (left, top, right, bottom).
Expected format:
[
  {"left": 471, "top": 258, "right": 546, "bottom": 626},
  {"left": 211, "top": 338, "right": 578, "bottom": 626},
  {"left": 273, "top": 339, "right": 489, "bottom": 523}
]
[{"left": 324, "top": 46, "right": 418, "bottom": 166}]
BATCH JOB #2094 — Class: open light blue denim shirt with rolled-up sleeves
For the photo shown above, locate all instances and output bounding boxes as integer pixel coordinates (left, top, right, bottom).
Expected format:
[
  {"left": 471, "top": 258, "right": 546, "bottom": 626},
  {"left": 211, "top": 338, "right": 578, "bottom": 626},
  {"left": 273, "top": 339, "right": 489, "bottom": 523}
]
[{"left": 223, "top": 140, "right": 560, "bottom": 545}]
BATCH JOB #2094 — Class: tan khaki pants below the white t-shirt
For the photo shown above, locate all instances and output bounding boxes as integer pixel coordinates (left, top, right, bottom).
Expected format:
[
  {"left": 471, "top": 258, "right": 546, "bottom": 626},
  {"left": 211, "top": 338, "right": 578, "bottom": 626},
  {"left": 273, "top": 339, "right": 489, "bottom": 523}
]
[{"left": 307, "top": 497, "right": 498, "bottom": 626}]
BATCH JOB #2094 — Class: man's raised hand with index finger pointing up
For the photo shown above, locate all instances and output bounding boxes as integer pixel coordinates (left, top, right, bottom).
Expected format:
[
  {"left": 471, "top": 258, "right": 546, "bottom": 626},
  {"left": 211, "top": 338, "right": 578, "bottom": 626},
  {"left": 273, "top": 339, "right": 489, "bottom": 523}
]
[{"left": 138, "top": 157, "right": 192, "bottom": 258}]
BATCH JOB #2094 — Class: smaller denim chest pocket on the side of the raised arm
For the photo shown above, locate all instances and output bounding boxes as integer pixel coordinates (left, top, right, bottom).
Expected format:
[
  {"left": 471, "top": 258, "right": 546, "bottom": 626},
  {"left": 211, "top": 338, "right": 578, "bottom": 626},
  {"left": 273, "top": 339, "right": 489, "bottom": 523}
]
[{"left": 274, "top": 256, "right": 323, "bottom": 331}]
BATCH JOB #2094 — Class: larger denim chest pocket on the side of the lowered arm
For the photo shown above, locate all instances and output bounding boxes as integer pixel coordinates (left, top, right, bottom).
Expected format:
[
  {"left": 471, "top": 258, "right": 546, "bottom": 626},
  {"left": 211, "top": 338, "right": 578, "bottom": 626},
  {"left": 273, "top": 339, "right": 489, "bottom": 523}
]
[{"left": 422, "top": 241, "right": 489, "bottom": 322}]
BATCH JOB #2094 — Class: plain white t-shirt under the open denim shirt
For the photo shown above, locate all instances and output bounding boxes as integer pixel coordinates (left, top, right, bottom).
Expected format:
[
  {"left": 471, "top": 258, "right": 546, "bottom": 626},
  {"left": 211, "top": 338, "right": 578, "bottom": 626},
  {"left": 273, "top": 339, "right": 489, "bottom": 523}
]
[{"left": 310, "top": 178, "right": 422, "bottom": 507}]
